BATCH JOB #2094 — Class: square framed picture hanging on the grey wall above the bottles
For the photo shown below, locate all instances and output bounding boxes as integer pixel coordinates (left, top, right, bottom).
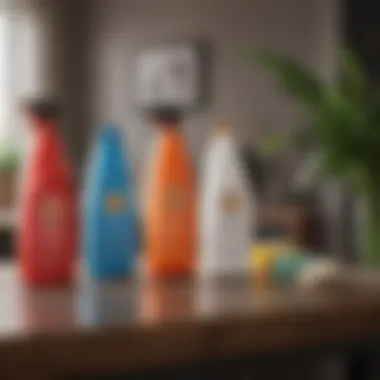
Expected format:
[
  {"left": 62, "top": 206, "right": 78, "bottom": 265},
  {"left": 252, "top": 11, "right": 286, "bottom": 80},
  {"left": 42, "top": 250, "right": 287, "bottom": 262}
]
[{"left": 137, "top": 42, "right": 205, "bottom": 110}]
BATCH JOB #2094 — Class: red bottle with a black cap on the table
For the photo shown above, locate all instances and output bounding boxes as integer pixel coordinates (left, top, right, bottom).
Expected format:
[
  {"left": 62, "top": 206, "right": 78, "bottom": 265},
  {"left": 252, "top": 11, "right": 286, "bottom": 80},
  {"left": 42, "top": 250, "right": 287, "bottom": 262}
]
[{"left": 17, "top": 100, "right": 77, "bottom": 285}]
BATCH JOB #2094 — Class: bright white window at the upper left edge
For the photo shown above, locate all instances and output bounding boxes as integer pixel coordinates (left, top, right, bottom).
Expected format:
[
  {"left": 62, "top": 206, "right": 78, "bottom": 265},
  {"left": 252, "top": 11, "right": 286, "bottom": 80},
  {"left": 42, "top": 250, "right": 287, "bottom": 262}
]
[{"left": 0, "top": 0, "right": 39, "bottom": 150}]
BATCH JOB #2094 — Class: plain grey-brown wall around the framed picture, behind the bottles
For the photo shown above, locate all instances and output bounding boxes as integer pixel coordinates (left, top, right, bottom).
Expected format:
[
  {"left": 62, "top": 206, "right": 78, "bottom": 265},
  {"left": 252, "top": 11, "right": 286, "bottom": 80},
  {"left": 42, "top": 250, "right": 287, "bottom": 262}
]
[{"left": 90, "top": 0, "right": 339, "bottom": 174}]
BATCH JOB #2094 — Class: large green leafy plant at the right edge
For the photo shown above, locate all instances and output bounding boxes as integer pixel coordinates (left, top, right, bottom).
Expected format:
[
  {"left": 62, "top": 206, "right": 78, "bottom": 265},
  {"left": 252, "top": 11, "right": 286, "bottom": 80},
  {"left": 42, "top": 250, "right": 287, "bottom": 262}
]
[{"left": 252, "top": 51, "right": 380, "bottom": 265}]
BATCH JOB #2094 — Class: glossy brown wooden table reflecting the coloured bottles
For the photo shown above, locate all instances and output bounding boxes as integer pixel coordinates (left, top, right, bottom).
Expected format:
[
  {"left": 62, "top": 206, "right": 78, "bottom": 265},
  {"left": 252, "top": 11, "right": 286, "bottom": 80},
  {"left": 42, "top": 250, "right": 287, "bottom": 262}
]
[{"left": 0, "top": 265, "right": 380, "bottom": 380}]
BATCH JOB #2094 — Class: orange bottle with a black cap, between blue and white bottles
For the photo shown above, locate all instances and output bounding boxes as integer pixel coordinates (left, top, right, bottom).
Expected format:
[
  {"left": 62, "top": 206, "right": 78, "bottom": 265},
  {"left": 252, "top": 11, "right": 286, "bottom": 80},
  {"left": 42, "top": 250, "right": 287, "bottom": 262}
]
[{"left": 144, "top": 110, "right": 196, "bottom": 277}]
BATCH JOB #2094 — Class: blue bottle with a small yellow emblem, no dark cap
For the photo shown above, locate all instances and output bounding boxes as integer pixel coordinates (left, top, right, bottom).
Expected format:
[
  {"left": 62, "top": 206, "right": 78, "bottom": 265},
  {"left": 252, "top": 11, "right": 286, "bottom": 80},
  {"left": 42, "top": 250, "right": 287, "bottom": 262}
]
[{"left": 82, "top": 125, "right": 140, "bottom": 280}]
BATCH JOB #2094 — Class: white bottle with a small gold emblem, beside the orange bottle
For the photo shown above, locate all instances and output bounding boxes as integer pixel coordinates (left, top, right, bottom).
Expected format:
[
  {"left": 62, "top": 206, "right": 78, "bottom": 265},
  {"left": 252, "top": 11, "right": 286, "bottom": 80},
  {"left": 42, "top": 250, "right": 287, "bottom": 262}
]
[{"left": 198, "top": 125, "right": 254, "bottom": 276}]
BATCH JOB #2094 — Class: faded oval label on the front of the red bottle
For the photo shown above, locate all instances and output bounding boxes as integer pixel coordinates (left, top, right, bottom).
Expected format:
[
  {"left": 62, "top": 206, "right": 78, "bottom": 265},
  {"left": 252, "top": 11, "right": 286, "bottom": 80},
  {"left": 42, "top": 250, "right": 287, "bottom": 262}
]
[{"left": 38, "top": 195, "right": 67, "bottom": 269}]
